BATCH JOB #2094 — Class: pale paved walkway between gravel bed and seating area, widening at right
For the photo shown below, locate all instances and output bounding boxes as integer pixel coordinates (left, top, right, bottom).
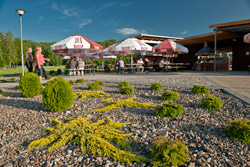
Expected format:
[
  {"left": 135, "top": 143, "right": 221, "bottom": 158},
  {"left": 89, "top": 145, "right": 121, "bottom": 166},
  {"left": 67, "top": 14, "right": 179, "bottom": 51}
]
[{"left": 0, "top": 71, "right": 250, "bottom": 104}]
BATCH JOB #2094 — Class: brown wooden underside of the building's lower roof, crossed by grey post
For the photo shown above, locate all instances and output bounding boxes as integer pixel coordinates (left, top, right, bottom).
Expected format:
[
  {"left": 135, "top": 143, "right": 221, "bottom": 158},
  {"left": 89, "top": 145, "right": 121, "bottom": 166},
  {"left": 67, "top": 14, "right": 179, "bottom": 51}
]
[{"left": 175, "top": 31, "right": 242, "bottom": 45}]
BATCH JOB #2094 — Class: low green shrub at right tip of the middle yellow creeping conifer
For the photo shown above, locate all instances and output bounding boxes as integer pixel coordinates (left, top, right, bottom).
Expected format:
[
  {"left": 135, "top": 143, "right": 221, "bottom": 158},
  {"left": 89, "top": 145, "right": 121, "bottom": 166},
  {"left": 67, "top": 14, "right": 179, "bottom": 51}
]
[{"left": 154, "top": 102, "right": 185, "bottom": 118}]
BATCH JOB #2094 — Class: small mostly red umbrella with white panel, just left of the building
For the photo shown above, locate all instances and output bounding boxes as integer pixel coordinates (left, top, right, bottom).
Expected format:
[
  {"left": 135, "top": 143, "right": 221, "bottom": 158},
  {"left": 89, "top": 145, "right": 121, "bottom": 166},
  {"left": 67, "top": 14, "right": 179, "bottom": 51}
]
[{"left": 154, "top": 39, "right": 188, "bottom": 55}]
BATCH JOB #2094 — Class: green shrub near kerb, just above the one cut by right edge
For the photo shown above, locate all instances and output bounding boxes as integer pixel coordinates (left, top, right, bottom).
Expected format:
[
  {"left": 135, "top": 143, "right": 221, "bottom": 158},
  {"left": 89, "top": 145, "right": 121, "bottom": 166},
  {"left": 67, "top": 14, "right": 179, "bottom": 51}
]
[{"left": 201, "top": 96, "right": 223, "bottom": 111}]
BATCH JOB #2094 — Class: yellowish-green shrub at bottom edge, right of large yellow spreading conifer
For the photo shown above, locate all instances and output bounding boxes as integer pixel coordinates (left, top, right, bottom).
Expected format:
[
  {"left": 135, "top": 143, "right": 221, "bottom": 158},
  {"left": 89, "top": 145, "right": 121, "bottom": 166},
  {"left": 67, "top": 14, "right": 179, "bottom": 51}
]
[{"left": 150, "top": 136, "right": 188, "bottom": 167}]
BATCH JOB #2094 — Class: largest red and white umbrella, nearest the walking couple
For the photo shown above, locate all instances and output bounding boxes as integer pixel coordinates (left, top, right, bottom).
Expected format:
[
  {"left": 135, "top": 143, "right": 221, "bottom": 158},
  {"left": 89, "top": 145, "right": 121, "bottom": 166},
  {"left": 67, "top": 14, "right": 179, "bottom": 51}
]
[{"left": 51, "top": 34, "right": 103, "bottom": 57}]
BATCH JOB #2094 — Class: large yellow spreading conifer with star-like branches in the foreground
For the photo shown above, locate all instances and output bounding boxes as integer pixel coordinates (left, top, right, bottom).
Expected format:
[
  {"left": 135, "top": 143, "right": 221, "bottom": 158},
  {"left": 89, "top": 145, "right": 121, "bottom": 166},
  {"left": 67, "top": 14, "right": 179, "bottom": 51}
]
[{"left": 28, "top": 117, "right": 147, "bottom": 164}]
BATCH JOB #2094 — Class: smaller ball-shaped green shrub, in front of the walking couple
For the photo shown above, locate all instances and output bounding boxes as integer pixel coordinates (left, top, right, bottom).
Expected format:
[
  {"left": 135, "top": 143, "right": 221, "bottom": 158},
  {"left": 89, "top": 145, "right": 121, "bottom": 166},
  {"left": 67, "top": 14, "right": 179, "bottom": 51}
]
[{"left": 19, "top": 72, "right": 42, "bottom": 97}]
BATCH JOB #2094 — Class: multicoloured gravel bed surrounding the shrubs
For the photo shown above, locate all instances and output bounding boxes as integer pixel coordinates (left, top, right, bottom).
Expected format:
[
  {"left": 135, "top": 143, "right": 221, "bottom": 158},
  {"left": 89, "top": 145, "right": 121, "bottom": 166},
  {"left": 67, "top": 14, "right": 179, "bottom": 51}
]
[{"left": 0, "top": 80, "right": 250, "bottom": 167}]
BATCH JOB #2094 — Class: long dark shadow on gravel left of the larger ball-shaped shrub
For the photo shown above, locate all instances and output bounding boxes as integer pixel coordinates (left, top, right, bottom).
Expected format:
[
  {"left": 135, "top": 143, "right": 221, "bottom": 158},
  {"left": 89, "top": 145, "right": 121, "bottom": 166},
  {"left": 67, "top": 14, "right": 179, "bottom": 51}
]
[{"left": 0, "top": 99, "right": 46, "bottom": 111}]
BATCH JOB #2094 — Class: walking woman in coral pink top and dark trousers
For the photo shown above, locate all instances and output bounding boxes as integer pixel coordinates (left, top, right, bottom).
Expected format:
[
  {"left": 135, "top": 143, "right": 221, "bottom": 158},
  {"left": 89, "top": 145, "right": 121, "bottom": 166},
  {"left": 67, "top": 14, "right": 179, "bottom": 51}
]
[{"left": 34, "top": 46, "right": 50, "bottom": 83}]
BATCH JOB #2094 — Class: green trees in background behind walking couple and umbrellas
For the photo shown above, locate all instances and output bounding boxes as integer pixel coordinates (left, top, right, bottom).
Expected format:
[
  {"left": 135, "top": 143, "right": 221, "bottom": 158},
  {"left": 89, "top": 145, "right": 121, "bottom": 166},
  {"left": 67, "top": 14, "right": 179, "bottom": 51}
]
[{"left": 0, "top": 31, "right": 119, "bottom": 68}]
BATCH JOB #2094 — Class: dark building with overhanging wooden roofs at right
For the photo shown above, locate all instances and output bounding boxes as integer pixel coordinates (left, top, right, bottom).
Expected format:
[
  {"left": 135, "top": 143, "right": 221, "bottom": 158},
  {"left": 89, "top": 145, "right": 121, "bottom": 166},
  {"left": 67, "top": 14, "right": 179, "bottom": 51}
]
[{"left": 175, "top": 19, "right": 250, "bottom": 70}]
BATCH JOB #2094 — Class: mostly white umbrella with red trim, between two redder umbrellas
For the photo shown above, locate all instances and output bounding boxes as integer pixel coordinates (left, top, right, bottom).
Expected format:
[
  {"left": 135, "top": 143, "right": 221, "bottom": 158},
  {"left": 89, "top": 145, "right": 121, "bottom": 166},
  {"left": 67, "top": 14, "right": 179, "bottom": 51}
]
[{"left": 113, "top": 38, "right": 153, "bottom": 55}]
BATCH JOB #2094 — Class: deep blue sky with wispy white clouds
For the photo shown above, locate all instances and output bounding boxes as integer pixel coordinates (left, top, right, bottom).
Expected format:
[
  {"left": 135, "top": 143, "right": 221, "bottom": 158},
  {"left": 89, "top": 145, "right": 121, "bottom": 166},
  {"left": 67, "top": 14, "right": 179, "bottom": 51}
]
[{"left": 0, "top": 0, "right": 250, "bottom": 42}]
